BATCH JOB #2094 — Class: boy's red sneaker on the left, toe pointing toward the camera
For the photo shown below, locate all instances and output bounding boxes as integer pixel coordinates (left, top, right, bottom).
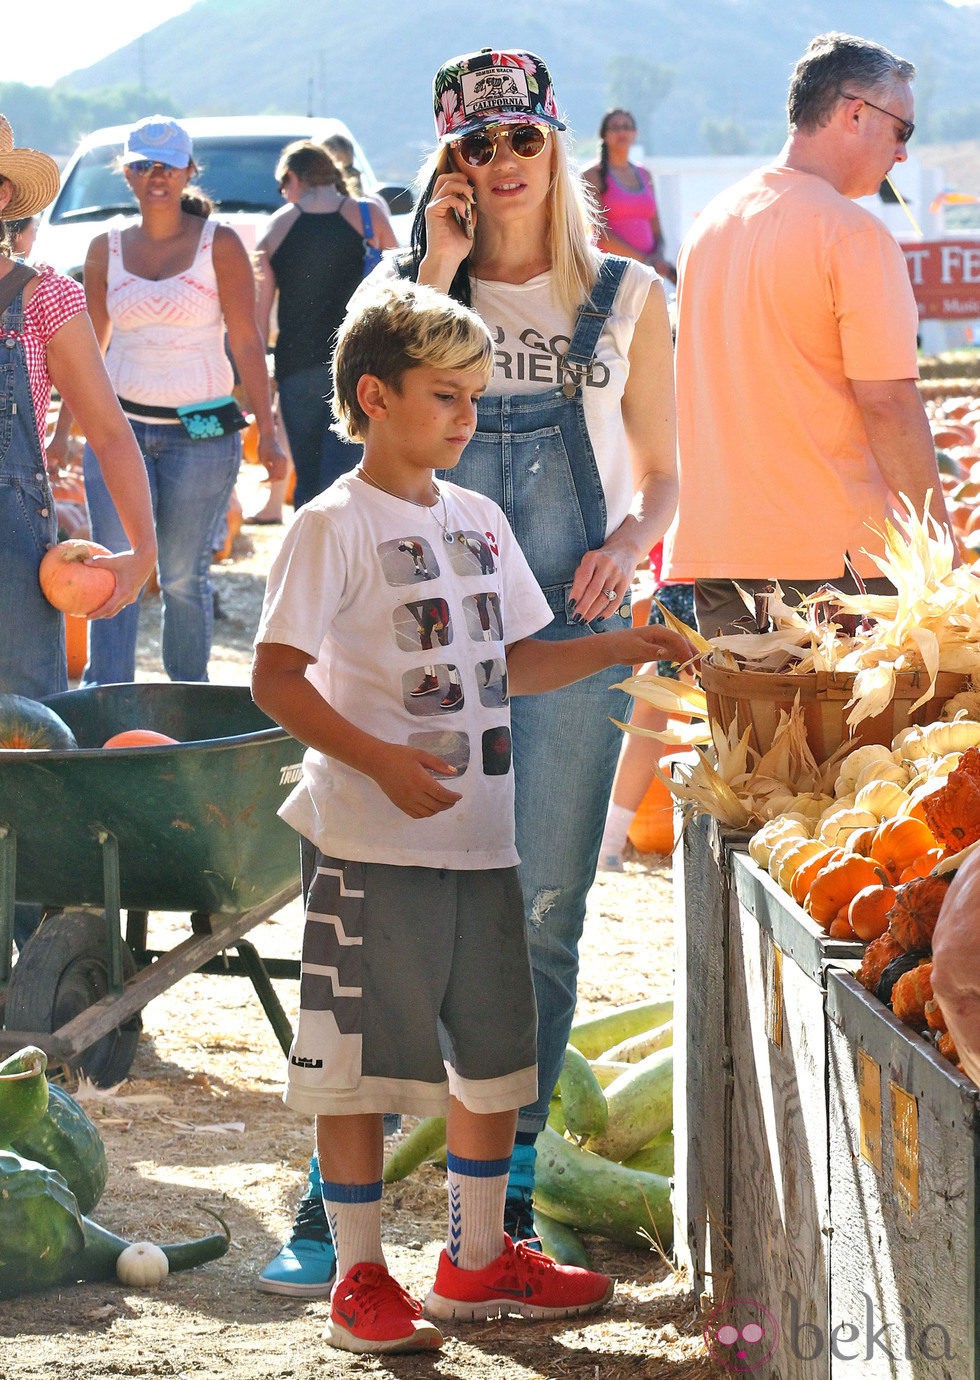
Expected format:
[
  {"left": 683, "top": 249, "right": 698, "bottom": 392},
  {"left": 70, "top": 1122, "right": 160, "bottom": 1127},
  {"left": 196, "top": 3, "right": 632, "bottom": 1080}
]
[{"left": 326, "top": 1261, "right": 444, "bottom": 1352}]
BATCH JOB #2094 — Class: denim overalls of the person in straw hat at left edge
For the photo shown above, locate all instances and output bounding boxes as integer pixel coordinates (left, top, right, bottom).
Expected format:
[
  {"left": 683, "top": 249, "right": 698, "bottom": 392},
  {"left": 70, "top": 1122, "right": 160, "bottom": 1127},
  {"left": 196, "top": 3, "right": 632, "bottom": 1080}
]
[{"left": 0, "top": 273, "right": 68, "bottom": 700}]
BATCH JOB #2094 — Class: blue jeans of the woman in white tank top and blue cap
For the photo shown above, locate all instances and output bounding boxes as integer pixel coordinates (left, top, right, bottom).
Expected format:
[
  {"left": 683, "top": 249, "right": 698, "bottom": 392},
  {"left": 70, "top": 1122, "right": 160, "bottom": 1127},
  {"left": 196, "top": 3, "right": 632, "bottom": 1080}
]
[{"left": 81, "top": 421, "right": 242, "bottom": 686}]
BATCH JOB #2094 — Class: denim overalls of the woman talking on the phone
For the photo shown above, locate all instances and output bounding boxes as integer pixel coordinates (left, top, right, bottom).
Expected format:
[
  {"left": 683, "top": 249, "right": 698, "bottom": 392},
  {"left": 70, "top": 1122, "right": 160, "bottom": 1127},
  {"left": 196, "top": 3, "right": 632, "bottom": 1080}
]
[{"left": 446, "top": 257, "right": 632, "bottom": 1132}]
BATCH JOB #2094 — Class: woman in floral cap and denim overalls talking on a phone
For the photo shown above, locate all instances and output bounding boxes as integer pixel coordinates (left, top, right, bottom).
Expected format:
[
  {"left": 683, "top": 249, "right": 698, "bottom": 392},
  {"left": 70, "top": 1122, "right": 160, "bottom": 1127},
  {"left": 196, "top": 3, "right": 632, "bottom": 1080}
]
[{"left": 256, "top": 48, "right": 676, "bottom": 1292}]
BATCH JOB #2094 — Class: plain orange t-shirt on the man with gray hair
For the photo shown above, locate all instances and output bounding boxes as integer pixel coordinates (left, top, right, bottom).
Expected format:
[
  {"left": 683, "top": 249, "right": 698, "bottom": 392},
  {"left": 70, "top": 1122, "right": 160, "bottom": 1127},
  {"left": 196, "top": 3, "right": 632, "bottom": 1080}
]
[{"left": 664, "top": 167, "right": 918, "bottom": 580}]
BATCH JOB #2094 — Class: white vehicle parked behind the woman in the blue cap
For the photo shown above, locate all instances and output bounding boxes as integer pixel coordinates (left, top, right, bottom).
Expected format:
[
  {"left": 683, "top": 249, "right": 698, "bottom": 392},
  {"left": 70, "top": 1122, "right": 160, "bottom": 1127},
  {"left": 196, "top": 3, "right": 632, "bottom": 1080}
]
[{"left": 32, "top": 115, "right": 413, "bottom": 280}]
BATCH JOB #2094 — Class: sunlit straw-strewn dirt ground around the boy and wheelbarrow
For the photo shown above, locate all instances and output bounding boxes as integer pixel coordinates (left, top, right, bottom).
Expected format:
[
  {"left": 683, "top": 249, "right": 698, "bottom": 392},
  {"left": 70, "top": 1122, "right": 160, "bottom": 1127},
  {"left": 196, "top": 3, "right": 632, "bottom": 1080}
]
[{"left": 0, "top": 468, "right": 723, "bottom": 1380}]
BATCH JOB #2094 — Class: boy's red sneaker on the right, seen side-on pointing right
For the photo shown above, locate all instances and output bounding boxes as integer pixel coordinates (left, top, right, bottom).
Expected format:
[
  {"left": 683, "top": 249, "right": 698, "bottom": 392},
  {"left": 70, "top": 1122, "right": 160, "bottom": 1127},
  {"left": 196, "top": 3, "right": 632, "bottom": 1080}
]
[{"left": 425, "top": 1236, "right": 613, "bottom": 1321}]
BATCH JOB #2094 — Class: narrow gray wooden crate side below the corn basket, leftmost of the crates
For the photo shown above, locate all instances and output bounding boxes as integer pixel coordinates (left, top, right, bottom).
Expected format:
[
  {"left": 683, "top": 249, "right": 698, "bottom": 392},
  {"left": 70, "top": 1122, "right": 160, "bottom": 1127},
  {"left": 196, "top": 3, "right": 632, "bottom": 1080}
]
[{"left": 674, "top": 816, "right": 751, "bottom": 1297}]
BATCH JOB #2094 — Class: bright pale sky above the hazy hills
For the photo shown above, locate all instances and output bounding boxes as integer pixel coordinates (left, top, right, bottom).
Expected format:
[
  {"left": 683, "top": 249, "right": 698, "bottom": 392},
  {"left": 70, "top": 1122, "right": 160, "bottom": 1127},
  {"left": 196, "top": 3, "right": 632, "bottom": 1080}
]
[{"left": 3, "top": 0, "right": 980, "bottom": 86}]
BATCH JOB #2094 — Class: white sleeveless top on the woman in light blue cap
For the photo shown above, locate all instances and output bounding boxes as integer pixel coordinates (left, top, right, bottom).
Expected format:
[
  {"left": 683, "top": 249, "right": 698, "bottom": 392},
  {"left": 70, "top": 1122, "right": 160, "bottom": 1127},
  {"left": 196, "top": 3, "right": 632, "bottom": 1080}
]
[{"left": 105, "top": 221, "right": 235, "bottom": 425}]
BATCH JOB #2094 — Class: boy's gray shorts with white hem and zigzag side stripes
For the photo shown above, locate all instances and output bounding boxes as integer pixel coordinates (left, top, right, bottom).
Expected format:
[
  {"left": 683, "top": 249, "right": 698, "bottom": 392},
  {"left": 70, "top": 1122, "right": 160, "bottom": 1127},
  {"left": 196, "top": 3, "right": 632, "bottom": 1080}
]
[{"left": 283, "top": 850, "right": 537, "bottom": 1116}]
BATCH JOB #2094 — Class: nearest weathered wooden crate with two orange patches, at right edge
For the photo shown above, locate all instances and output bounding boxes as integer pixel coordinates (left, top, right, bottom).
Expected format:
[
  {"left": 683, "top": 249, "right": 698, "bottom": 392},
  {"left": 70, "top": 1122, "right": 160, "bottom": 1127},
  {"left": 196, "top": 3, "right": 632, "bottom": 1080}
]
[{"left": 828, "top": 973, "right": 980, "bottom": 1380}]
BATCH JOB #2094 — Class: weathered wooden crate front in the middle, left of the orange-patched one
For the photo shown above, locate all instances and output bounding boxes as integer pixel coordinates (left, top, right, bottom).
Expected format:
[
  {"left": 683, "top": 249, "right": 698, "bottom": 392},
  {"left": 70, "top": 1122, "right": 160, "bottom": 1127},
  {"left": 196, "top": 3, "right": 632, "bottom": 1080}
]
[{"left": 715, "top": 856, "right": 859, "bottom": 1380}]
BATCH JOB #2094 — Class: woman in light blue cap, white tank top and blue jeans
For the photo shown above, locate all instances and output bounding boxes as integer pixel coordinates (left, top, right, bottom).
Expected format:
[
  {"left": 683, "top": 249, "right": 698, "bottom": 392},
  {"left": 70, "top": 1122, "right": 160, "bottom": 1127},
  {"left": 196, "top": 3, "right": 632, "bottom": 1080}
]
[{"left": 70, "top": 116, "right": 287, "bottom": 684}]
